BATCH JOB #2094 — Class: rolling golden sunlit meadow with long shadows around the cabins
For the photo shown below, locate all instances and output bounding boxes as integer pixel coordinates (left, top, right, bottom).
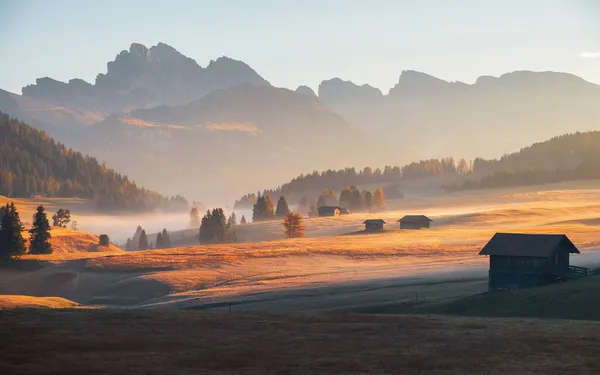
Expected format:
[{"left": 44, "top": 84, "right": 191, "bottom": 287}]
[{"left": 0, "top": 181, "right": 600, "bottom": 311}]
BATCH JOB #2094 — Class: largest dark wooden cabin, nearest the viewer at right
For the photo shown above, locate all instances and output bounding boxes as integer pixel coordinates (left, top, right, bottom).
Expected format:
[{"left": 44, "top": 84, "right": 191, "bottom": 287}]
[{"left": 479, "top": 233, "right": 579, "bottom": 292}]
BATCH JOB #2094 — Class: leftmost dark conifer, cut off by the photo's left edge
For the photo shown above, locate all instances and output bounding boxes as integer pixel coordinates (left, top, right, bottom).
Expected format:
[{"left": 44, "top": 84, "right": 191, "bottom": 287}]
[{"left": 0, "top": 203, "right": 26, "bottom": 264}]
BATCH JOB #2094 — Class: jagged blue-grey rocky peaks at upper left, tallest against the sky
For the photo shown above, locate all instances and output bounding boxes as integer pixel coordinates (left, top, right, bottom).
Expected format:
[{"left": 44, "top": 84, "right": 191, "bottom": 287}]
[{"left": 22, "top": 43, "right": 268, "bottom": 115}]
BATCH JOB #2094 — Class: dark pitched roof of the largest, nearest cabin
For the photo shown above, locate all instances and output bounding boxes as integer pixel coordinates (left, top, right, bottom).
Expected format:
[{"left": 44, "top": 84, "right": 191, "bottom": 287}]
[{"left": 479, "top": 233, "right": 579, "bottom": 258}]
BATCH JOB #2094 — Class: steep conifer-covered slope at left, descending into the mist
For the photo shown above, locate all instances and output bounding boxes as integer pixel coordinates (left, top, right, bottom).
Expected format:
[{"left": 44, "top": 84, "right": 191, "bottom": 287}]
[{"left": 0, "top": 112, "right": 188, "bottom": 211}]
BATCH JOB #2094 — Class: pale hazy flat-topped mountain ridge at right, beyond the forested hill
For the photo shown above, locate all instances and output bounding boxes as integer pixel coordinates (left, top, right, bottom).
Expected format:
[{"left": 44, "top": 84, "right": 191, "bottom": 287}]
[{"left": 319, "top": 71, "right": 600, "bottom": 158}]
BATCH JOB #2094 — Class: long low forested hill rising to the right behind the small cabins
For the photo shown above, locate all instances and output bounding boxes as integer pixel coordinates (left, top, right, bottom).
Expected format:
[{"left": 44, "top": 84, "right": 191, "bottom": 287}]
[{"left": 236, "top": 131, "right": 600, "bottom": 207}]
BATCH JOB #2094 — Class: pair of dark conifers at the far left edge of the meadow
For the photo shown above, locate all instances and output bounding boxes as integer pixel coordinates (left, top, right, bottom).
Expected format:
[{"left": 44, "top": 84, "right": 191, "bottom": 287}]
[{"left": 0, "top": 203, "right": 52, "bottom": 265}]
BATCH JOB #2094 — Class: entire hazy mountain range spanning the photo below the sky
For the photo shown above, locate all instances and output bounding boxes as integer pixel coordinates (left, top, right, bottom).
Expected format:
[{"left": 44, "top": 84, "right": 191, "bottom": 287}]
[{"left": 0, "top": 43, "right": 600, "bottom": 201}]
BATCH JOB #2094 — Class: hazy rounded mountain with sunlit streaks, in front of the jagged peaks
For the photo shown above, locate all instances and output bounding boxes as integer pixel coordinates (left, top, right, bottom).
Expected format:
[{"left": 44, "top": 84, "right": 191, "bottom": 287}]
[{"left": 80, "top": 84, "right": 414, "bottom": 202}]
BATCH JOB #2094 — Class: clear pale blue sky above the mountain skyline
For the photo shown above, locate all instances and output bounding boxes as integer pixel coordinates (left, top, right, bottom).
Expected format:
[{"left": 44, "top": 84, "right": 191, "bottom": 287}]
[{"left": 0, "top": 0, "right": 600, "bottom": 93}]
